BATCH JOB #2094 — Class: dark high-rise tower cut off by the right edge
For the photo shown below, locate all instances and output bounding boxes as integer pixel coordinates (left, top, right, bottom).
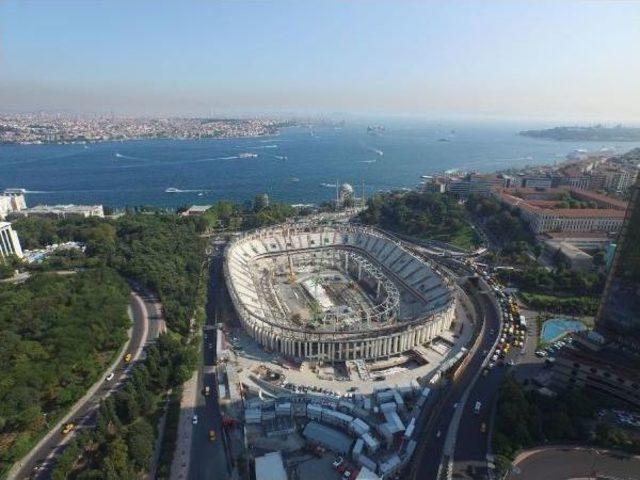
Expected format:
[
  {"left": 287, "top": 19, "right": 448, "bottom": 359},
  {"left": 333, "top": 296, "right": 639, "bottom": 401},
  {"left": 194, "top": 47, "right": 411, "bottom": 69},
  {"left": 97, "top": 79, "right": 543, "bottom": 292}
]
[{"left": 597, "top": 177, "right": 640, "bottom": 346}]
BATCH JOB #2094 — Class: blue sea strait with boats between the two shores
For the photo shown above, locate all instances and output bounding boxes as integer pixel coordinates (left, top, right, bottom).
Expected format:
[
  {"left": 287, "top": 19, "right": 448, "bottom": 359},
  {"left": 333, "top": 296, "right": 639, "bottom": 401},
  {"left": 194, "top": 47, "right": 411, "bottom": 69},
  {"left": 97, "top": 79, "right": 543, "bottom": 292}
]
[{"left": 0, "top": 119, "right": 640, "bottom": 208}]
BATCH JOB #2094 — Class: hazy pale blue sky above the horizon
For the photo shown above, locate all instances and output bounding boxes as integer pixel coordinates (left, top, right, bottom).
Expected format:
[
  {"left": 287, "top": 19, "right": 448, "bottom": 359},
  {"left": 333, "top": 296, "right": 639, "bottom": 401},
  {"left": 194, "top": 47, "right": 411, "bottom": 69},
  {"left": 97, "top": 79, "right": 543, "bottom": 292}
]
[{"left": 0, "top": 0, "right": 640, "bottom": 124}]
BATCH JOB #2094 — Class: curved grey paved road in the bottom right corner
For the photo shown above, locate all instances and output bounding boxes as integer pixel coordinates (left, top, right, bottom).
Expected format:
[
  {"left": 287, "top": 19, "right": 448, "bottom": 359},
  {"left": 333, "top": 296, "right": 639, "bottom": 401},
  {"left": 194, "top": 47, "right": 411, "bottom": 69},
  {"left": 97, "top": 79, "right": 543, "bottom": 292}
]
[{"left": 508, "top": 447, "right": 640, "bottom": 480}]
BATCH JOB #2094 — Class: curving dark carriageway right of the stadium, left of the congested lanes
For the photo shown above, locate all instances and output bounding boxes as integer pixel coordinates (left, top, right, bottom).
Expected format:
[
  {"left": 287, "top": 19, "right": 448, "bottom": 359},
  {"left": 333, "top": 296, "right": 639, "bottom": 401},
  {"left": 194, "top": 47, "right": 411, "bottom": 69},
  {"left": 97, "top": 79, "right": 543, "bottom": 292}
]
[{"left": 412, "top": 284, "right": 500, "bottom": 480}]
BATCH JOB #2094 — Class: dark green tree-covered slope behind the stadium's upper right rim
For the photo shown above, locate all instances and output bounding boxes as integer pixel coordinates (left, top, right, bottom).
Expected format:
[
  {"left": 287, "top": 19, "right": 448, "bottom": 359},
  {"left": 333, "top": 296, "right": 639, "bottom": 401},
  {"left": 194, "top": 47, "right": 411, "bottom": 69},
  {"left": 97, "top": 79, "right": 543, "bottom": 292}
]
[{"left": 361, "top": 192, "right": 477, "bottom": 248}]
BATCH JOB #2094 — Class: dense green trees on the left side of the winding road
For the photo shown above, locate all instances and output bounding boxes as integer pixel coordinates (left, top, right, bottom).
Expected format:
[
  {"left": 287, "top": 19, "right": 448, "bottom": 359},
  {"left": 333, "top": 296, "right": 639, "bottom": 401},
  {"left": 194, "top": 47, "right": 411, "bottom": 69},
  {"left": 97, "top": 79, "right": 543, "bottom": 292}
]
[{"left": 0, "top": 268, "right": 129, "bottom": 472}]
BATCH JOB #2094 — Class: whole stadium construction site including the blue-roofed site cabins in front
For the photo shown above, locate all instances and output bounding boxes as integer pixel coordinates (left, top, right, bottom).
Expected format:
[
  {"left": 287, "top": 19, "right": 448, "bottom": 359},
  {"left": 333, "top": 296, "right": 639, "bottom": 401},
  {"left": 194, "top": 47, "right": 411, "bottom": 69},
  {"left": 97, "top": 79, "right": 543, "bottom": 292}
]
[{"left": 211, "top": 224, "right": 484, "bottom": 480}]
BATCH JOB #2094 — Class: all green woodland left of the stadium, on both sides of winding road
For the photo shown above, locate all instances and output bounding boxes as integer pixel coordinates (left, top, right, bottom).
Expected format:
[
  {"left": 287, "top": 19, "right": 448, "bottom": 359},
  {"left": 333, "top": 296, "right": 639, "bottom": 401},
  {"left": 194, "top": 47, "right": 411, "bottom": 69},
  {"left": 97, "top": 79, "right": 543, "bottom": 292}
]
[{"left": 5, "top": 213, "right": 208, "bottom": 480}]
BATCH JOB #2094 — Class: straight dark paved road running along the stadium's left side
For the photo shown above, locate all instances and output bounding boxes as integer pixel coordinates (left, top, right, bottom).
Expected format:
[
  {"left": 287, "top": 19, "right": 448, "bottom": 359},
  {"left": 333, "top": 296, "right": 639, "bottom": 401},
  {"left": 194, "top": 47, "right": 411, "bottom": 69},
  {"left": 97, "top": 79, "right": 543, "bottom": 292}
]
[{"left": 189, "top": 256, "right": 229, "bottom": 480}]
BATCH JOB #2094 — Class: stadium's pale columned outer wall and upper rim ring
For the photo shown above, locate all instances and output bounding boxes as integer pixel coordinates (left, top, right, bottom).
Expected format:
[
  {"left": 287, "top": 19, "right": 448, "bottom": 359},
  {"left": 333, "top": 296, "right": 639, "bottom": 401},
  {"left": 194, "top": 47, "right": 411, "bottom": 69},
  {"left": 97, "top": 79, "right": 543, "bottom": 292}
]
[{"left": 224, "top": 226, "right": 456, "bottom": 362}]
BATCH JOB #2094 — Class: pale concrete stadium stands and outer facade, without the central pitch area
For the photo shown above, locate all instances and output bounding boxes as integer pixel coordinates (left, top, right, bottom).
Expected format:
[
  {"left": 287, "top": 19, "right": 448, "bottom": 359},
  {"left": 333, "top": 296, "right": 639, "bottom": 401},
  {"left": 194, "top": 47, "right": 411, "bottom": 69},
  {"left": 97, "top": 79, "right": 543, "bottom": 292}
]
[{"left": 225, "top": 226, "right": 455, "bottom": 362}]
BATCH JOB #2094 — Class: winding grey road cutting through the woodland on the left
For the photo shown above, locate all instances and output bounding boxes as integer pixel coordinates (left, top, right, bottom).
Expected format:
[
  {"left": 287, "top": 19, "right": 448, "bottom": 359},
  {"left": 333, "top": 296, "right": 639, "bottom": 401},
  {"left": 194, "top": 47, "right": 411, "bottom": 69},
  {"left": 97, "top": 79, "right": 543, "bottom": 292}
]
[{"left": 10, "top": 288, "right": 164, "bottom": 480}]
